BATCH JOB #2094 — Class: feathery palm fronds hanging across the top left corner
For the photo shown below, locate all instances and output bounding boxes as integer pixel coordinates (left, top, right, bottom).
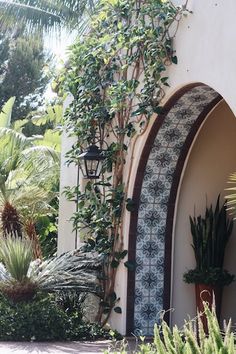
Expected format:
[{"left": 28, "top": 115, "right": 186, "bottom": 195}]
[{"left": 0, "top": 0, "right": 96, "bottom": 32}]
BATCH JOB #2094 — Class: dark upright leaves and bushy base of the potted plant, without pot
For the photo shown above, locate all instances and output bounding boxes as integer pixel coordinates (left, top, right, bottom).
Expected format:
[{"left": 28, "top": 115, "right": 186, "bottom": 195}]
[{"left": 184, "top": 196, "right": 234, "bottom": 285}]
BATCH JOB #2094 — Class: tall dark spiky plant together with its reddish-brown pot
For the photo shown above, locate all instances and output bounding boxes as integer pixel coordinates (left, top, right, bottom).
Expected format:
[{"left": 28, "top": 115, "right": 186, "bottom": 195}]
[{"left": 184, "top": 196, "right": 234, "bottom": 331}]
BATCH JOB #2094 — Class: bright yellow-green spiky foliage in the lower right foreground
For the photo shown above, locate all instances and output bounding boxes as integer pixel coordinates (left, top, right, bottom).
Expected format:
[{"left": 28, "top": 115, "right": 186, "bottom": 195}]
[{"left": 104, "top": 304, "right": 236, "bottom": 354}]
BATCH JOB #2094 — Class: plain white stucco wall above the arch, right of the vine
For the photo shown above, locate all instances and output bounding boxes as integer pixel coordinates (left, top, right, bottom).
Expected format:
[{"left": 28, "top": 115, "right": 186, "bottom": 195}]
[{"left": 168, "top": 0, "right": 236, "bottom": 113}]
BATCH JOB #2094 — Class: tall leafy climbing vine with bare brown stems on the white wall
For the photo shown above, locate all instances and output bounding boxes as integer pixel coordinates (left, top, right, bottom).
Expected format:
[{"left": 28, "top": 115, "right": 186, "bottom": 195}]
[{"left": 60, "top": 0, "right": 186, "bottom": 323}]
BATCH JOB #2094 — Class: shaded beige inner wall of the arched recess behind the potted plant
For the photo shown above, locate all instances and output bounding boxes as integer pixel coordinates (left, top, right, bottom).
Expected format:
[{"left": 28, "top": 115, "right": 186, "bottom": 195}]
[{"left": 172, "top": 102, "right": 236, "bottom": 325}]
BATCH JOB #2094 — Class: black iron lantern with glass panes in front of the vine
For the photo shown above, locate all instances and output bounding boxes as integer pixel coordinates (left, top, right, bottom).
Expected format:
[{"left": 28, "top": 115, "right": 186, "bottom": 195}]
[{"left": 78, "top": 145, "right": 105, "bottom": 179}]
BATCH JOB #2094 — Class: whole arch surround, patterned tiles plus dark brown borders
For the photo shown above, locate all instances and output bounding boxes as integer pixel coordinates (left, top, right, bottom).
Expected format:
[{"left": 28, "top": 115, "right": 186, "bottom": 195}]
[{"left": 127, "top": 84, "right": 222, "bottom": 335}]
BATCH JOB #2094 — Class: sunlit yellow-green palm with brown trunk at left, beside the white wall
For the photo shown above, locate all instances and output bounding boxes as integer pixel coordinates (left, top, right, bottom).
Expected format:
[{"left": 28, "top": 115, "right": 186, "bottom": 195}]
[{"left": 0, "top": 128, "right": 59, "bottom": 258}]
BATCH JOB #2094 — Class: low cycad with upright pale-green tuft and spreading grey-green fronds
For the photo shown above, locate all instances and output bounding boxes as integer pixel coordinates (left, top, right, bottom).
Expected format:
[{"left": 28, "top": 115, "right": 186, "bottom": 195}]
[{"left": 0, "top": 238, "right": 101, "bottom": 301}]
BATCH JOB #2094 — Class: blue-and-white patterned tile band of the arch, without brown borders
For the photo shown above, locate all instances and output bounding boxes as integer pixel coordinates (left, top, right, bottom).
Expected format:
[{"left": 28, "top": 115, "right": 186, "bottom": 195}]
[{"left": 134, "top": 86, "right": 219, "bottom": 335}]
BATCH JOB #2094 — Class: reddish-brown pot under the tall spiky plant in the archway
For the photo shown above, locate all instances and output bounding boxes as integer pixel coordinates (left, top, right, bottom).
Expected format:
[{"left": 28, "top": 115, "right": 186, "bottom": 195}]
[{"left": 195, "top": 284, "right": 223, "bottom": 333}]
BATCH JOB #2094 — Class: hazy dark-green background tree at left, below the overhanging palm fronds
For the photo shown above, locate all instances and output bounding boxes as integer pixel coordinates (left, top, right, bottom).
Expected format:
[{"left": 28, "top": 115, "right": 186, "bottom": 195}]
[{"left": 0, "top": 33, "right": 48, "bottom": 121}]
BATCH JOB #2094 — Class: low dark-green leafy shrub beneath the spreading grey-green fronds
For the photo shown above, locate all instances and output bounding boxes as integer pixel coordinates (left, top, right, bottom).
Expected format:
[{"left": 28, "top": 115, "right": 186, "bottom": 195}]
[{"left": 0, "top": 296, "right": 71, "bottom": 341}]
